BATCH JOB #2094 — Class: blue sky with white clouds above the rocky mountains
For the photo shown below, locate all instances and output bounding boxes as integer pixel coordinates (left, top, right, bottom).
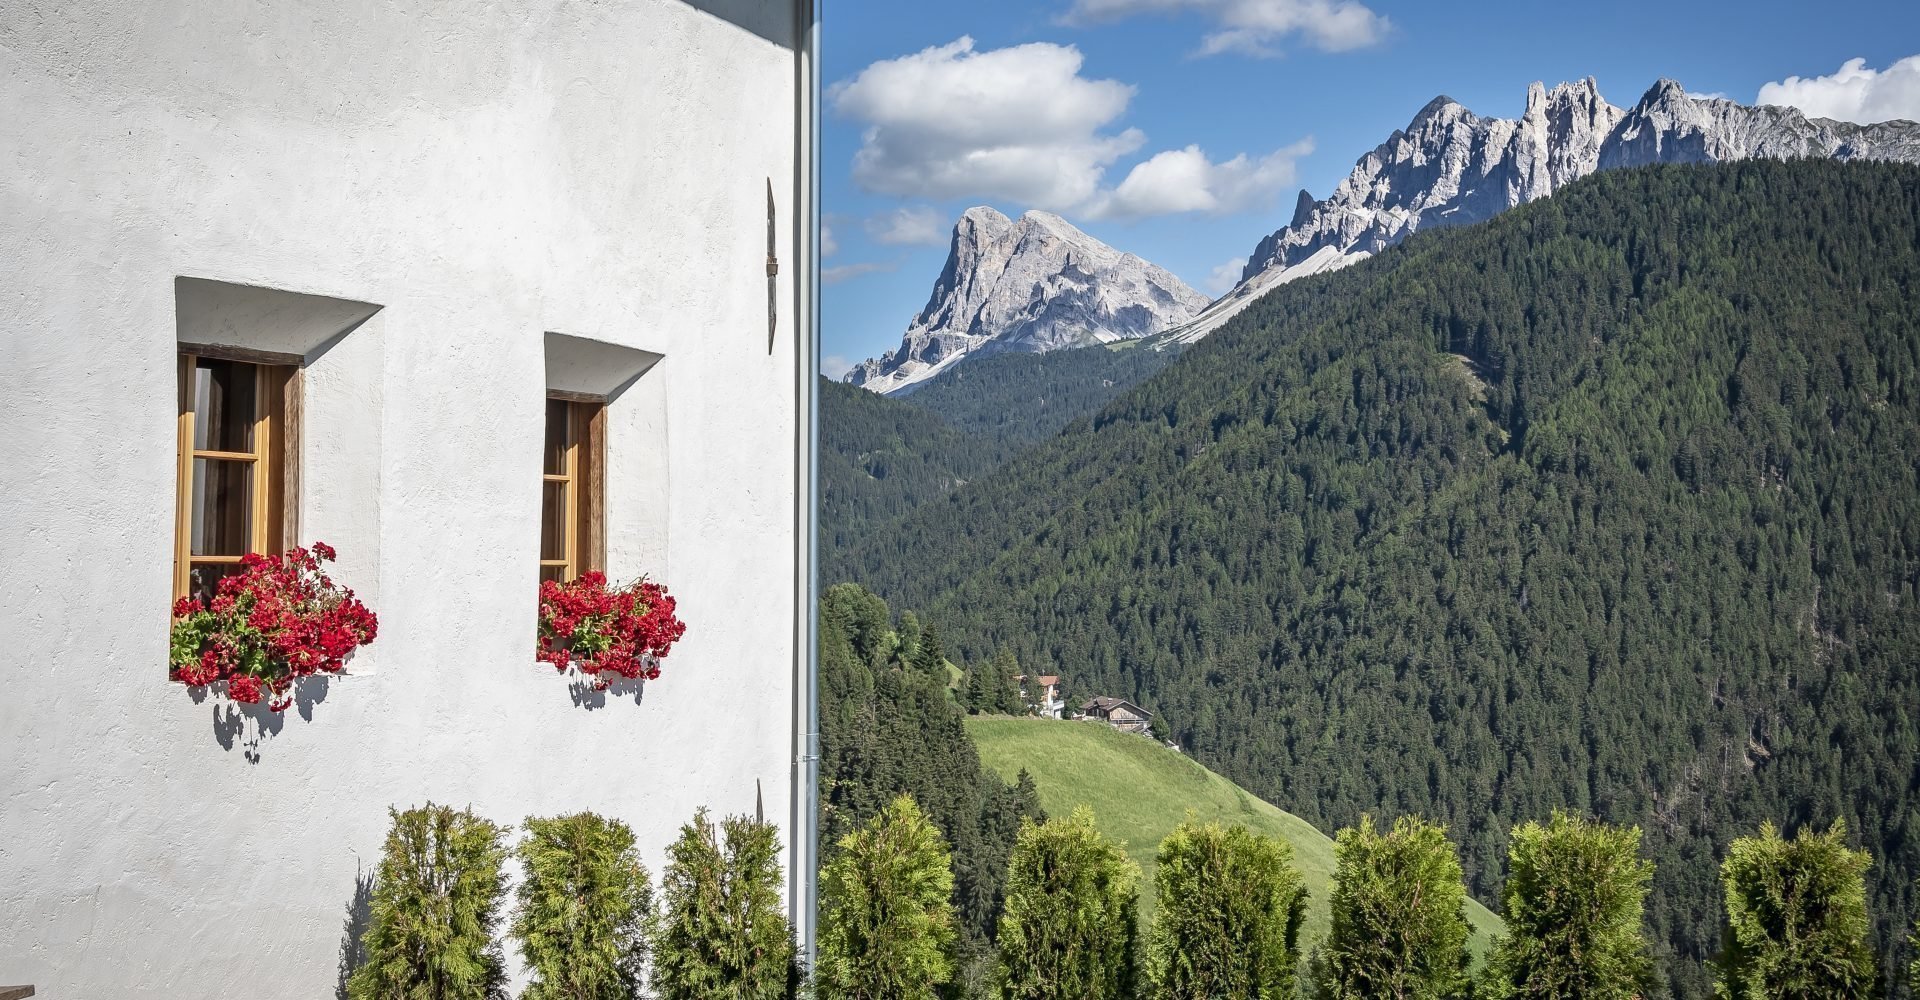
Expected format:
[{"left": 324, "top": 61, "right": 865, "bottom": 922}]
[{"left": 822, "top": 0, "right": 1920, "bottom": 376}]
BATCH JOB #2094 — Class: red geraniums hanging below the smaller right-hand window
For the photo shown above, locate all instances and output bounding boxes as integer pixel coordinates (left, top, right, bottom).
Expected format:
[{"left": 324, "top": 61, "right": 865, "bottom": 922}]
[{"left": 534, "top": 572, "right": 687, "bottom": 691}]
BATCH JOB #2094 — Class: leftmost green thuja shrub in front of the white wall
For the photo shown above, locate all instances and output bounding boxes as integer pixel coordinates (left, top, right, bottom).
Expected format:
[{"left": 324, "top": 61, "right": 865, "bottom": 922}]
[{"left": 348, "top": 802, "right": 507, "bottom": 1000}]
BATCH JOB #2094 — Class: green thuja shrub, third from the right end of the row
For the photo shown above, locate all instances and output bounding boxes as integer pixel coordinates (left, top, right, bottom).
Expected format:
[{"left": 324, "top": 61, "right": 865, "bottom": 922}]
[{"left": 1321, "top": 816, "right": 1467, "bottom": 1000}]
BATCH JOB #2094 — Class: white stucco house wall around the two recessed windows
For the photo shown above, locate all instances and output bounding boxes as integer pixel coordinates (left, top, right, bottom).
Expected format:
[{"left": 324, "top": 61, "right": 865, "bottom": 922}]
[{"left": 0, "top": 0, "right": 799, "bottom": 998}]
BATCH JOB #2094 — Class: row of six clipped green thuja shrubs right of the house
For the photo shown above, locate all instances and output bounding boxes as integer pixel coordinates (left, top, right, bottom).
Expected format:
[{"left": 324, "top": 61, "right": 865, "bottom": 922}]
[{"left": 814, "top": 798, "right": 1872, "bottom": 1000}]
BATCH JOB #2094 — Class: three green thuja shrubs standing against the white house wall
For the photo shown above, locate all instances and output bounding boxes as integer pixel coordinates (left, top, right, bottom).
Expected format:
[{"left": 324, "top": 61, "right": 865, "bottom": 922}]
[{"left": 348, "top": 802, "right": 799, "bottom": 1000}]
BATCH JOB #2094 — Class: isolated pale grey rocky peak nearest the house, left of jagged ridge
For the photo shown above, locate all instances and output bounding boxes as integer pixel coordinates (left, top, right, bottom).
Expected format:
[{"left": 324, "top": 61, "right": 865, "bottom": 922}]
[{"left": 847, "top": 207, "right": 1208, "bottom": 392}]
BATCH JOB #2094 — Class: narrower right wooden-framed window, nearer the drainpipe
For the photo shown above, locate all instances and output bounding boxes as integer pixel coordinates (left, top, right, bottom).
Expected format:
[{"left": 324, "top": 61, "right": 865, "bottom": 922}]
[{"left": 540, "top": 399, "right": 607, "bottom": 582}]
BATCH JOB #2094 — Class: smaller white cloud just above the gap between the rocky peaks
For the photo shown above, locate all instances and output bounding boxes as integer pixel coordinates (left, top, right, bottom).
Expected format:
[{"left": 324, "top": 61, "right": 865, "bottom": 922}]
[{"left": 1087, "top": 138, "right": 1313, "bottom": 219}]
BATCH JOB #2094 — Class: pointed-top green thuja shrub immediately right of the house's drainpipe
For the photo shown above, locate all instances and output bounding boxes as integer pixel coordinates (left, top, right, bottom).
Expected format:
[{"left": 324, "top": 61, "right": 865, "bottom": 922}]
[{"left": 814, "top": 795, "right": 954, "bottom": 1000}]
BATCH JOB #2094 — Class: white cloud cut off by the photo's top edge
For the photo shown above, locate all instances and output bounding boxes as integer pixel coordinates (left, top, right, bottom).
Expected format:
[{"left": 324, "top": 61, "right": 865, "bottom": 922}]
[{"left": 1068, "top": 0, "right": 1392, "bottom": 56}]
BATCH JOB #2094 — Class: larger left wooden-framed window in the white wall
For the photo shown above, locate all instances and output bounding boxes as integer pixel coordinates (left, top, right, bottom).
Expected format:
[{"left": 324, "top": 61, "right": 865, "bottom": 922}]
[{"left": 173, "top": 351, "right": 298, "bottom": 599}]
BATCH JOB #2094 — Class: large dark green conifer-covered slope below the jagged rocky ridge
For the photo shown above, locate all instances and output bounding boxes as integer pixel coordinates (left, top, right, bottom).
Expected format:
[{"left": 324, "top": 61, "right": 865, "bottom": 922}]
[{"left": 829, "top": 161, "right": 1920, "bottom": 996}]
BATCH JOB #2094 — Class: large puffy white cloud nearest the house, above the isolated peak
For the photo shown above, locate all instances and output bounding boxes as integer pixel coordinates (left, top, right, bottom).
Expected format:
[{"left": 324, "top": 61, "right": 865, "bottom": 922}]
[{"left": 828, "top": 36, "right": 1146, "bottom": 211}]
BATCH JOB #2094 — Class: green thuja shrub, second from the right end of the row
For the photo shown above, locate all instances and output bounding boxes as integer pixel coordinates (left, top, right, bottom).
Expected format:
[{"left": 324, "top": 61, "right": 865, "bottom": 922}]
[{"left": 1486, "top": 810, "right": 1653, "bottom": 1000}]
